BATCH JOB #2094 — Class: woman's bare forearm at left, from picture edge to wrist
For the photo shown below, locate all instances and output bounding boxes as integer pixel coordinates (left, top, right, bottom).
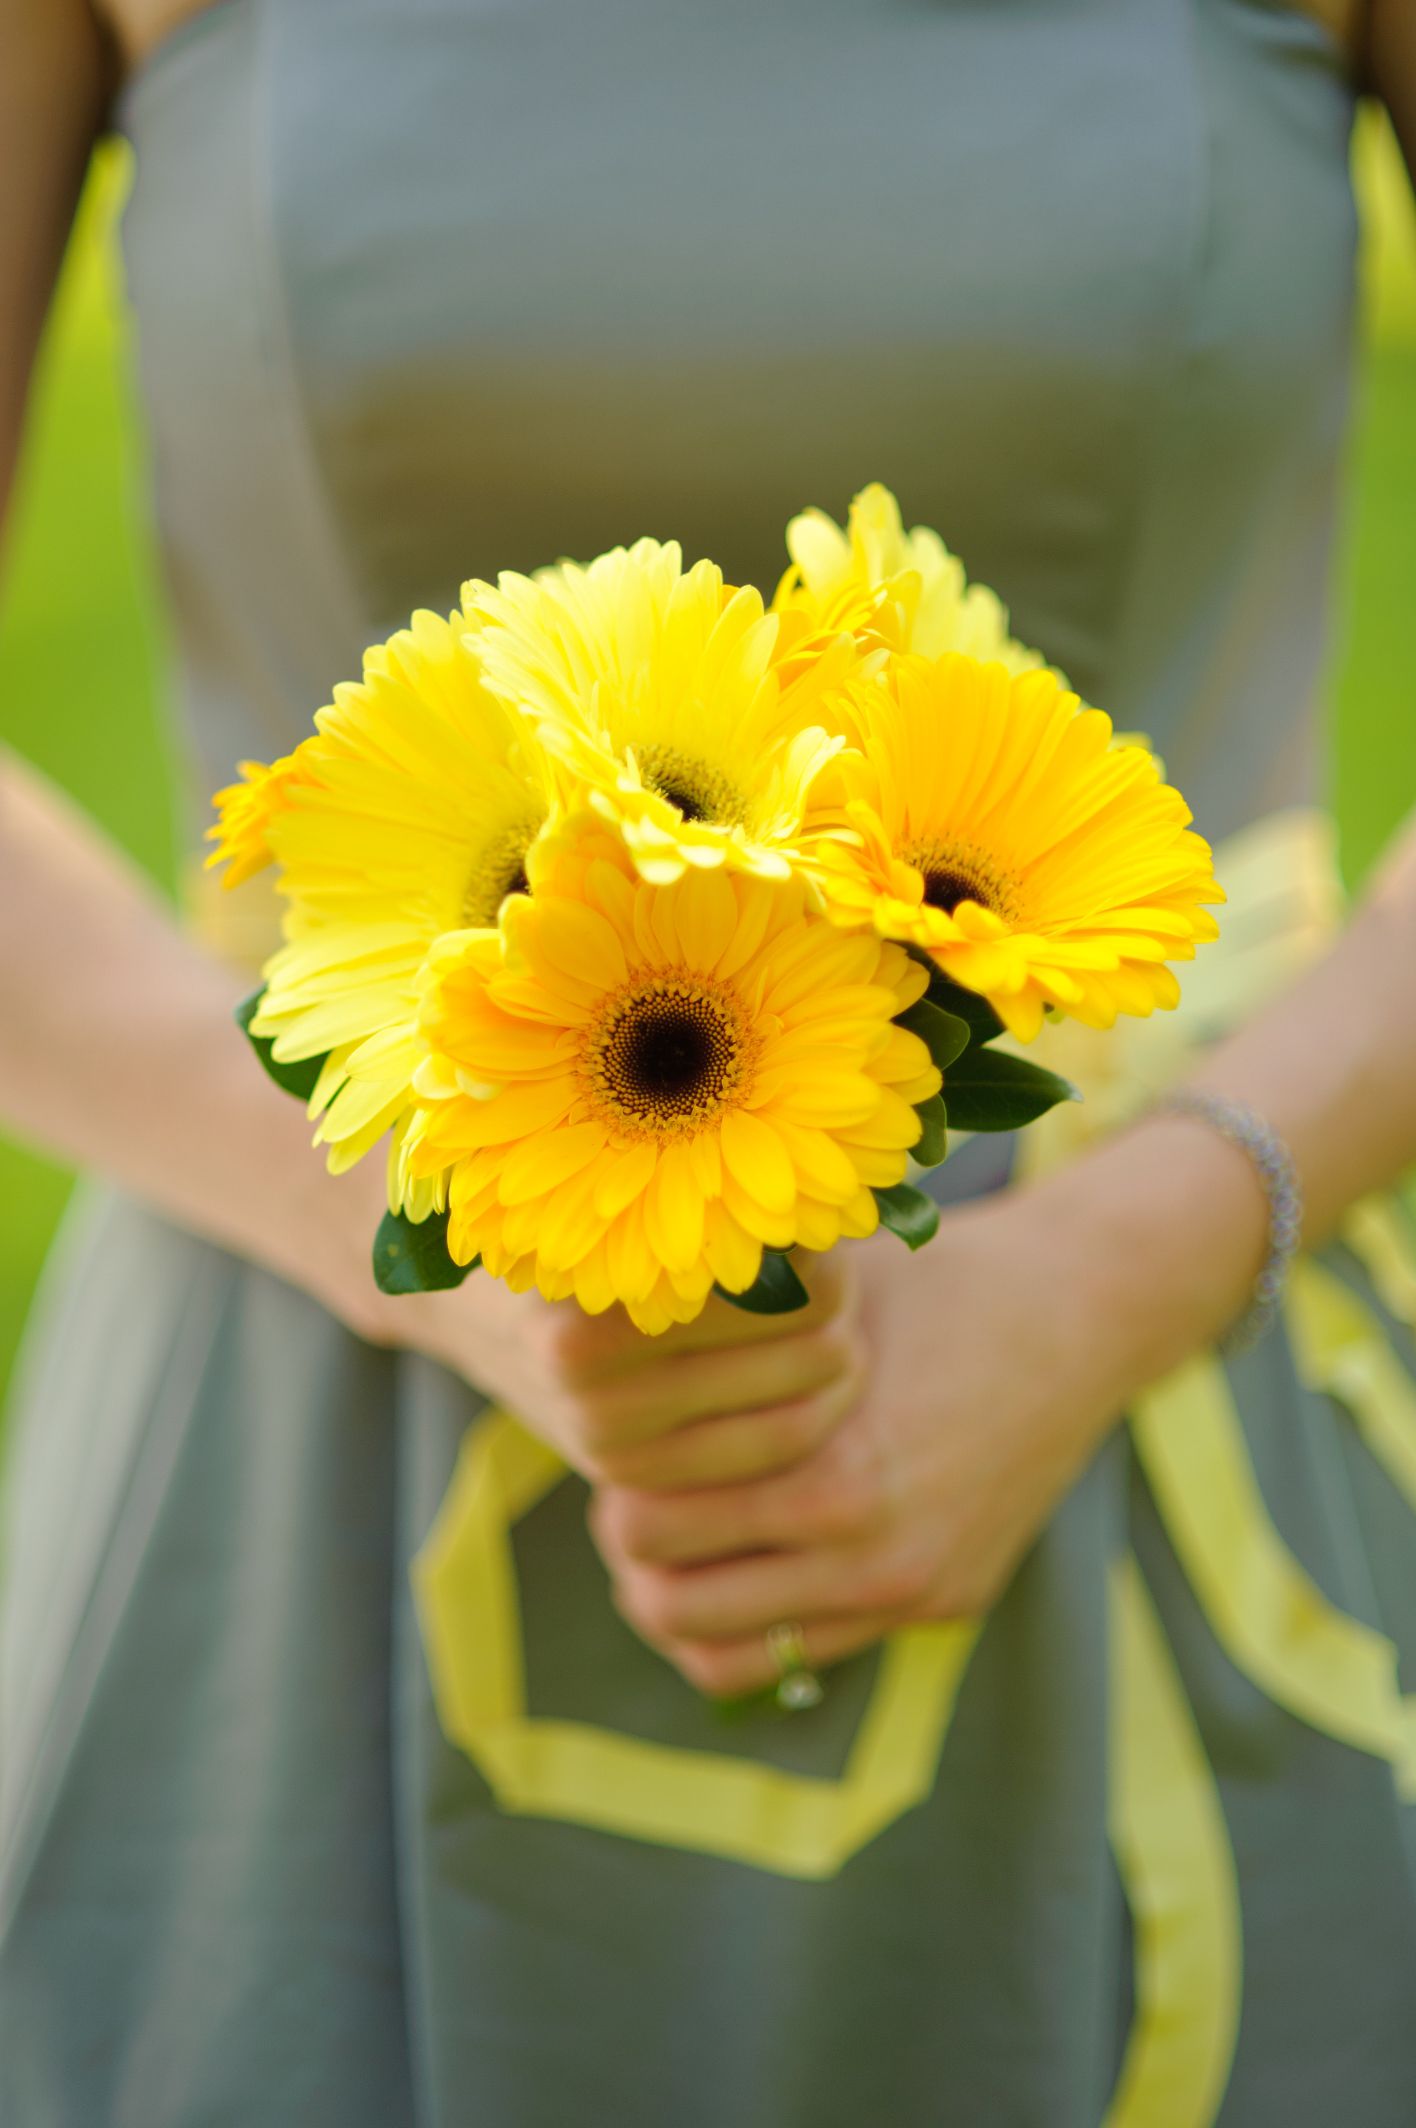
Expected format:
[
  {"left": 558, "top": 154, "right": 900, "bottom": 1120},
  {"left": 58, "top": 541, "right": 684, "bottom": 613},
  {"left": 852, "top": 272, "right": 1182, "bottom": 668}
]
[{"left": 0, "top": 760, "right": 381, "bottom": 1328}]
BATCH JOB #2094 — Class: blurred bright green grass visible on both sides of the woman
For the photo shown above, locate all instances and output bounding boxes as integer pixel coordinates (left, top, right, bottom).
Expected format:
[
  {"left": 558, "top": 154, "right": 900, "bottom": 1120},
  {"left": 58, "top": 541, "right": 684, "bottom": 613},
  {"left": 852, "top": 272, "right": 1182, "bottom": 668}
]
[{"left": 0, "top": 113, "right": 1416, "bottom": 1392}]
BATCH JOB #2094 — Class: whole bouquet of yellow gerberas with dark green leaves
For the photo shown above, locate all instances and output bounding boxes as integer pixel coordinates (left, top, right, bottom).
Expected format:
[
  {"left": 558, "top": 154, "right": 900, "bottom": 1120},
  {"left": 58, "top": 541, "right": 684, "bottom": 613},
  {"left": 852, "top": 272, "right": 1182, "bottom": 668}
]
[{"left": 211, "top": 487, "right": 1222, "bottom": 1332}]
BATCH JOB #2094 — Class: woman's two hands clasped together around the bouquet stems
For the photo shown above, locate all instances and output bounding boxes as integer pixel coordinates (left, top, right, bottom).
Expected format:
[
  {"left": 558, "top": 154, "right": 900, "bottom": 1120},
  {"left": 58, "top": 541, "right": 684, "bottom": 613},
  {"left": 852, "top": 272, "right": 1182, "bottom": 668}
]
[{"left": 417, "top": 1198, "right": 1116, "bottom": 1696}]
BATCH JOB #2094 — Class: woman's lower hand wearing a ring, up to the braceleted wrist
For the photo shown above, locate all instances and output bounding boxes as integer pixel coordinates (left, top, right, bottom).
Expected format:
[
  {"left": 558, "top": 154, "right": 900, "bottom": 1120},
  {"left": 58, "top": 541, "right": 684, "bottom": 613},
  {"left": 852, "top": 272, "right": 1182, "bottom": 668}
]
[{"left": 592, "top": 1119, "right": 1263, "bottom": 1696}]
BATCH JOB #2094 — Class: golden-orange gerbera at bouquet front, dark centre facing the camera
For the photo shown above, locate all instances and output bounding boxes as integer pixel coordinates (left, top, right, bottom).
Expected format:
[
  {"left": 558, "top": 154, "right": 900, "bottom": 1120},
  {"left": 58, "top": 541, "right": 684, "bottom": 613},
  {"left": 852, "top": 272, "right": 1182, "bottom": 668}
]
[{"left": 405, "top": 830, "right": 939, "bottom": 1332}]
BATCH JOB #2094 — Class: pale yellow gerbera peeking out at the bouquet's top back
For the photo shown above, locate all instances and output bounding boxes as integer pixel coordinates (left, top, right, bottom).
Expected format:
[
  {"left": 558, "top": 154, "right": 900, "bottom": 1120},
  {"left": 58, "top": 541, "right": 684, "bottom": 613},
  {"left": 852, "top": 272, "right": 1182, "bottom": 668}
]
[{"left": 773, "top": 481, "right": 1041, "bottom": 672}]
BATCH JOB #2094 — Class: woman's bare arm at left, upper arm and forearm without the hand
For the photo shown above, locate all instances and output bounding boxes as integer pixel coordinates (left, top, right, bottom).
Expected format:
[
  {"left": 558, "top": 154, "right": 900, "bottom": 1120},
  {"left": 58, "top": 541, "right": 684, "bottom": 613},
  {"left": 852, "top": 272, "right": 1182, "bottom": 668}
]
[{"left": 0, "top": 25, "right": 391, "bottom": 1319}]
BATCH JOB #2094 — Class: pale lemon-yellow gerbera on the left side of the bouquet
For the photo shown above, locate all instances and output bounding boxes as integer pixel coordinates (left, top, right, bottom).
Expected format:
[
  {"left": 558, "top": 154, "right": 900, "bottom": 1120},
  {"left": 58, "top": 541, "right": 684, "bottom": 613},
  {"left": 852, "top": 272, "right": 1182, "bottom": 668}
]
[{"left": 217, "top": 613, "right": 556, "bottom": 1198}]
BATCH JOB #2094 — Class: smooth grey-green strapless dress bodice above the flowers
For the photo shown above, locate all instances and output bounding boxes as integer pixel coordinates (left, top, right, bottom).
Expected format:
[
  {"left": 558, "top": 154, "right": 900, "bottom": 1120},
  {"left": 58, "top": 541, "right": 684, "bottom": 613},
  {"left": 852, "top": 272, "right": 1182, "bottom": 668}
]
[{"left": 124, "top": 0, "right": 1354, "bottom": 836}]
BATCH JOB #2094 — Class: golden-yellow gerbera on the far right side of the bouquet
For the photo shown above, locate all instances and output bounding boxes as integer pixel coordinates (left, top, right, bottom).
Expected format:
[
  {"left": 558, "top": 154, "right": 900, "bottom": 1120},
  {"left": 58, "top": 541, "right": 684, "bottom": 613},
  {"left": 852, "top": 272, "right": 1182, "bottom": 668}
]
[{"left": 807, "top": 655, "right": 1224, "bottom": 1041}]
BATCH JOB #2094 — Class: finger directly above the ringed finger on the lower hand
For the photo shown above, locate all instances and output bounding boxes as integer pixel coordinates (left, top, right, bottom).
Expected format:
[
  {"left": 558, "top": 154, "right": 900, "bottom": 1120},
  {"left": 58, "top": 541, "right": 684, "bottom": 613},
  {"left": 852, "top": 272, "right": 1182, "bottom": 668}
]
[{"left": 615, "top": 1547, "right": 877, "bottom": 1647}]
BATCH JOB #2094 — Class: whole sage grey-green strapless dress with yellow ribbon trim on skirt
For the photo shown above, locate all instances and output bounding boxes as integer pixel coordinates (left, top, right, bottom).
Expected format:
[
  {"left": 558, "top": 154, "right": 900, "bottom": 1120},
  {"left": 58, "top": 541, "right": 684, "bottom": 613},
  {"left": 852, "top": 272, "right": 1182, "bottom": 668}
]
[{"left": 0, "top": 0, "right": 1416, "bottom": 2128}]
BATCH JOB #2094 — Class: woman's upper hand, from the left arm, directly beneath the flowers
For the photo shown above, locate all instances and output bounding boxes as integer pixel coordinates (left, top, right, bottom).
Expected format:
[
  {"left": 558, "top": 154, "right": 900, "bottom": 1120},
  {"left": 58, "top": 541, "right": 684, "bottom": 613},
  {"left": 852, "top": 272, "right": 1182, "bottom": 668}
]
[{"left": 375, "top": 1251, "right": 865, "bottom": 1498}]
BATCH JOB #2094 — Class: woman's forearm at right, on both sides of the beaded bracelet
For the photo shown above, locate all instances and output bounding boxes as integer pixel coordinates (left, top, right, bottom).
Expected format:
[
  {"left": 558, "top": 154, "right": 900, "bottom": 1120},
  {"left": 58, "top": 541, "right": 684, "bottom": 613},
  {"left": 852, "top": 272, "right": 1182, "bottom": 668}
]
[{"left": 1035, "top": 812, "right": 1416, "bottom": 1398}]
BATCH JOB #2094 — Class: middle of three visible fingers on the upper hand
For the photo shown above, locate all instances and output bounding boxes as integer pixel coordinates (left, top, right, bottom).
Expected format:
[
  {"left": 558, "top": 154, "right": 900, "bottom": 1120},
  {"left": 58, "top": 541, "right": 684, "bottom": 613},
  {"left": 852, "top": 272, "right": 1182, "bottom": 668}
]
[{"left": 596, "top": 1324, "right": 862, "bottom": 1449}]
